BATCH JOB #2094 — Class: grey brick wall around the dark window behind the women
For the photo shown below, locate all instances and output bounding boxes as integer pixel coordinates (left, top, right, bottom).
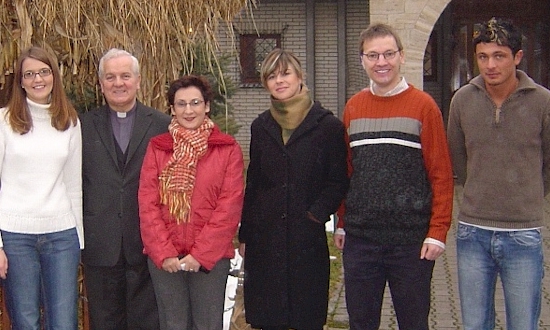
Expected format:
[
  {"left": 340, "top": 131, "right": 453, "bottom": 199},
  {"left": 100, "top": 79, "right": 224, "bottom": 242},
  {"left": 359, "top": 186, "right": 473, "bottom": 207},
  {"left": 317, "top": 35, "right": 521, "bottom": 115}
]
[{"left": 218, "top": 0, "right": 376, "bottom": 160}]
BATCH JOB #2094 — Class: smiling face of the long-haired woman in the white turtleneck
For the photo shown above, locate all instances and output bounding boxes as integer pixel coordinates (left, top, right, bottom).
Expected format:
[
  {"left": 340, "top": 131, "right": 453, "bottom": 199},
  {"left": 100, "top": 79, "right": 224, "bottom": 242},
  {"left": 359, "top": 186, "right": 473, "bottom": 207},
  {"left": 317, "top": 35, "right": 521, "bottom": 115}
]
[{"left": 21, "top": 57, "right": 53, "bottom": 104}]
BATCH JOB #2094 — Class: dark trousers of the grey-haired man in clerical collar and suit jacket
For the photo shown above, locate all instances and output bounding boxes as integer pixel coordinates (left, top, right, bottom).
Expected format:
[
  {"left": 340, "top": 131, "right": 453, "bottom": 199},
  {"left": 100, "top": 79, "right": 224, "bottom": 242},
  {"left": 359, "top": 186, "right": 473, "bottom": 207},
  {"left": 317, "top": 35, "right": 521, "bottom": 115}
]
[{"left": 84, "top": 254, "right": 159, "bottom": 330}]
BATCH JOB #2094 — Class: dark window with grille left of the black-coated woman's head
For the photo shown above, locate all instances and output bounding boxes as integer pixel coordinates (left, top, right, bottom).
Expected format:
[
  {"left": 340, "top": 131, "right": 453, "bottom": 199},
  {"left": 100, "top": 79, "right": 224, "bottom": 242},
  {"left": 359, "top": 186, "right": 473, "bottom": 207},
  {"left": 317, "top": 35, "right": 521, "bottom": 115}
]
[{"left": 240, "top": 34, "right": 281, "bottom": 86}]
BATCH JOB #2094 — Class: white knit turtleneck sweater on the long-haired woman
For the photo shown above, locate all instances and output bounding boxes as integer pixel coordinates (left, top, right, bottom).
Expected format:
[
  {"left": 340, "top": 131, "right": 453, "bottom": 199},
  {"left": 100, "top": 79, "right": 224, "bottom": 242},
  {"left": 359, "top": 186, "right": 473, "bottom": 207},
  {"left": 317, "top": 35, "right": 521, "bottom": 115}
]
[{"left": 0, "top": 99, "right": 84, "bottom": 249}]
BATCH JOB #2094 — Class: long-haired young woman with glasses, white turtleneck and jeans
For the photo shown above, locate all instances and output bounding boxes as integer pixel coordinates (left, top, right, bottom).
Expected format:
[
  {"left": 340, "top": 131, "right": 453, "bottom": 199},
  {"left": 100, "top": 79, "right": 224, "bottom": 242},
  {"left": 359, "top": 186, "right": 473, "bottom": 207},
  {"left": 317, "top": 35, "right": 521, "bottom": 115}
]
[{"left": 0, "top": 47, "right": 84, "bottom": 330}]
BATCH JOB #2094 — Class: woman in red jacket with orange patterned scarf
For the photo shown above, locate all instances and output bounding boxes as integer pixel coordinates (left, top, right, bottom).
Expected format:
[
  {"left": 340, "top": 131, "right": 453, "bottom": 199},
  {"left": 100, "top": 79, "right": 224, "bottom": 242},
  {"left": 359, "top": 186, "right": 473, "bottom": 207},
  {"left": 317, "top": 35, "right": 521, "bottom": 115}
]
[{"left": 139, "top": 76, "right": 244, "bottom": 330}]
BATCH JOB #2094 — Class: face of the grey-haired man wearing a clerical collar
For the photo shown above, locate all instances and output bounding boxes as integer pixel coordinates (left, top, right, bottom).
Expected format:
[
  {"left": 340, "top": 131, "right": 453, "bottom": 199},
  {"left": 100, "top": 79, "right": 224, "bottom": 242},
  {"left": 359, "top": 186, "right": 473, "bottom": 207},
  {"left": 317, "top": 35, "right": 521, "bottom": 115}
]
[{"left": 99, "top": 56, "right": 141, "bottom": 112}]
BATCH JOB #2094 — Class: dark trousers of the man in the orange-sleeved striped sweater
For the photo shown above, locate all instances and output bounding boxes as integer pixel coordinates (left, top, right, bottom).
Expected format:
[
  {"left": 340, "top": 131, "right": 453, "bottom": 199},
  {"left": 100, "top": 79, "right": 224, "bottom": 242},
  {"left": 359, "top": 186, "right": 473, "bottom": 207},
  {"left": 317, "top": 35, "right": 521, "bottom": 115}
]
[{"left": 343, "top": 235, "right": 435, "bottom": 330}]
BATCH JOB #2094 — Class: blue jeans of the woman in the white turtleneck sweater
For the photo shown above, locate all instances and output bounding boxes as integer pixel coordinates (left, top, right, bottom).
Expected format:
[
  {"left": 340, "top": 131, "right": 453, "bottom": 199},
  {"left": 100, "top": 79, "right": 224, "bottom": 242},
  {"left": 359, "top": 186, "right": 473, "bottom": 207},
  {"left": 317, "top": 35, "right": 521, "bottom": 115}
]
[{"left": 2, "top": 228, "right": 80, "bottom": 330}]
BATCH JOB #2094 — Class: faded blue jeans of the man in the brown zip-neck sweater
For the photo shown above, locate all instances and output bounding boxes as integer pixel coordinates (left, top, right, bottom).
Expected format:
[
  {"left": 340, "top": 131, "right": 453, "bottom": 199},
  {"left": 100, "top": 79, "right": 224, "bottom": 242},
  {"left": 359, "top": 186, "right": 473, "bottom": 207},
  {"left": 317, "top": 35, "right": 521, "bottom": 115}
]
[{"left": 457, "top": 224, "right": 544, "bottom": 330}]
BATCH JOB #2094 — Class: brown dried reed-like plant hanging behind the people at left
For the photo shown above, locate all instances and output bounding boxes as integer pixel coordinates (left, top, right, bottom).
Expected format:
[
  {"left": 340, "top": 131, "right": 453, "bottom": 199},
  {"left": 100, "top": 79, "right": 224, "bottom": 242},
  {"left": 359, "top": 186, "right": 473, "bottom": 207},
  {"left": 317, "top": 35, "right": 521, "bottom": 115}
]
[{"left": 0, "top": 0, "right": 256, "bottom": 110}]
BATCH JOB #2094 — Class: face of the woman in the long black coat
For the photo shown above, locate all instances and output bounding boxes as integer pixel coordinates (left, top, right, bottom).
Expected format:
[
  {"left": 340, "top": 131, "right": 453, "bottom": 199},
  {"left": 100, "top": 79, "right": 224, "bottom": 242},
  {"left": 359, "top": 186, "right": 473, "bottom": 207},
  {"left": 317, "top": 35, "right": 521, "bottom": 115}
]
[{"left": 266, "top": 65, "right": 302, "bottom": 101}]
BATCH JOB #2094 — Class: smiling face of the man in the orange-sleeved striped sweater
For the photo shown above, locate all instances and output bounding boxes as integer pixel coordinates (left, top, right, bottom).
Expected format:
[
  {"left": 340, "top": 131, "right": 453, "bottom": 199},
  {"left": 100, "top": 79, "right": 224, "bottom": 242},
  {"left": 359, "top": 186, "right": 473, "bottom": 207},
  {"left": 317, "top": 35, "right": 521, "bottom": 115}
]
[{"left": 361, "top": 35, "right": 405, "bottom": 94}]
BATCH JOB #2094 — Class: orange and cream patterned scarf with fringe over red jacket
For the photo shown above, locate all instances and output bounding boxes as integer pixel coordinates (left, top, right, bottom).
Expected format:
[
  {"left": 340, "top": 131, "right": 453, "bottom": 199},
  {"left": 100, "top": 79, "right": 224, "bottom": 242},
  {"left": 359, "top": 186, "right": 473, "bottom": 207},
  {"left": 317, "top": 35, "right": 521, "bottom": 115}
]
[{"left": 159, "top": 117, "right": 214, "bottom": 224}]
